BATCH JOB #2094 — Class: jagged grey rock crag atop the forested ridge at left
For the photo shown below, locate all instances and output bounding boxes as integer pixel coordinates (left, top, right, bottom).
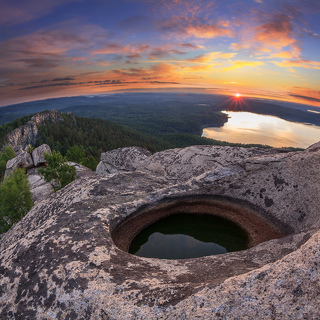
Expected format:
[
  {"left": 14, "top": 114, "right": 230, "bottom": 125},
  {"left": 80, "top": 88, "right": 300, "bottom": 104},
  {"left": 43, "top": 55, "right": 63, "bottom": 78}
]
[{"left": 6, "top": 110, "right": 63, "bottom": 149}]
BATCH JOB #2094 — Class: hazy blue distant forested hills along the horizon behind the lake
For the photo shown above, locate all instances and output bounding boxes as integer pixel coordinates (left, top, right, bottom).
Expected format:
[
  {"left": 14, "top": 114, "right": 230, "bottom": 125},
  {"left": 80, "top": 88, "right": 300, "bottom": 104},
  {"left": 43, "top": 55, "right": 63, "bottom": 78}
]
[{"left": 0, "top": 93, "right": 320, "bottom": 136}]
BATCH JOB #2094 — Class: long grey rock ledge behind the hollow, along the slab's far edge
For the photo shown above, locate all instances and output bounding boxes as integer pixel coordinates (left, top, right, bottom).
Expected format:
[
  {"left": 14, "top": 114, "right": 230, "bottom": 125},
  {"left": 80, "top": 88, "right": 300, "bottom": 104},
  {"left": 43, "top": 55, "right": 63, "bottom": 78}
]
[{"left": 96, "top": 146, "right": 288, "bottom": 183}]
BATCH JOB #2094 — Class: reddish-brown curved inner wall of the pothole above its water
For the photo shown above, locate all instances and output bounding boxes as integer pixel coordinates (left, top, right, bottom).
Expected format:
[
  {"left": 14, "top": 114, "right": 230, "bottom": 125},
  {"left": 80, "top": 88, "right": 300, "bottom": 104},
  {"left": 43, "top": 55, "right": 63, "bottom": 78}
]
[{"left": 112, "top": 197, "right": 285, "bottom": 258}]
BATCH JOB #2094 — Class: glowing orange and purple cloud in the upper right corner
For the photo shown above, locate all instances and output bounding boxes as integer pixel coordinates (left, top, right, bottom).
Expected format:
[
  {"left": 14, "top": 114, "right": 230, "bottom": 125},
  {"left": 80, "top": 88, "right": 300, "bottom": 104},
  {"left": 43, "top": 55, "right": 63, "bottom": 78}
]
[{"left": 230, "top": 0, "right": 318, "bottom": 59}]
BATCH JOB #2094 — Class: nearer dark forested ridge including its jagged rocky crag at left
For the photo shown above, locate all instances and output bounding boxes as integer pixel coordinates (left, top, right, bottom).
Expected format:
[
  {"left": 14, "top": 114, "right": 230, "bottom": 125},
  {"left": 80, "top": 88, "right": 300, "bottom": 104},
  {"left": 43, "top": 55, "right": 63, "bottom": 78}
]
[{"left": 0, "top": 110, "right": 282, "bottom": 169}]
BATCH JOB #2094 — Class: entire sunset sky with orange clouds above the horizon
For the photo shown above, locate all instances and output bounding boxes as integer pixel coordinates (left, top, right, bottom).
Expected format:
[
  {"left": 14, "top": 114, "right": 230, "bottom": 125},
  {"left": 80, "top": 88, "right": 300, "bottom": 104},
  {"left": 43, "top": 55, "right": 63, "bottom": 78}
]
[{"left": 0, "top": 0, "right": 320, "bottom": 107}]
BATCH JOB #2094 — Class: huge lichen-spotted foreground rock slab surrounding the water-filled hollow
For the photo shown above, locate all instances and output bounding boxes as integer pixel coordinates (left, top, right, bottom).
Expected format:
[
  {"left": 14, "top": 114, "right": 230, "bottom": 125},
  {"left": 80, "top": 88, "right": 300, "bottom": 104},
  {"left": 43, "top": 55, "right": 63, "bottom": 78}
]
[{"left": 0, "top": 147, "right": 320, "bottom": 320}]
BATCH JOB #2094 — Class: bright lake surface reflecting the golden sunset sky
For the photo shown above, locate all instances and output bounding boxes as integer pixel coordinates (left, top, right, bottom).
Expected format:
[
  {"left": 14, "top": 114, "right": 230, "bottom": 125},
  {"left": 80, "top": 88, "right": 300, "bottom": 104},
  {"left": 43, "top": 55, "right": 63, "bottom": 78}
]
[{"left": 202, "top": 111, "right": 320, "bottom": 148}]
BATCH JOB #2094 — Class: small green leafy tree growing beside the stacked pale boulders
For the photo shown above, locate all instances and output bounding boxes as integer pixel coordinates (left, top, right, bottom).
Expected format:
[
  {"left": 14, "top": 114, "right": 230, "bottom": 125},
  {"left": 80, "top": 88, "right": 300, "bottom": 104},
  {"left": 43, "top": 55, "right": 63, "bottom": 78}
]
[{"left": 38, "top": 151, "right": 76, "bottom": 191}]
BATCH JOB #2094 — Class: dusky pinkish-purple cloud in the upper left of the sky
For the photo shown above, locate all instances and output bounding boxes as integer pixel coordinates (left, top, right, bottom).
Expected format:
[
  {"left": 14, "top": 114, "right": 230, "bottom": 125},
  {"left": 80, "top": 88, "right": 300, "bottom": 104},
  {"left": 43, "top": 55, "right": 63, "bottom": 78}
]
[{"left": 0, "top": 23, "right": 108, "bottom": 80}]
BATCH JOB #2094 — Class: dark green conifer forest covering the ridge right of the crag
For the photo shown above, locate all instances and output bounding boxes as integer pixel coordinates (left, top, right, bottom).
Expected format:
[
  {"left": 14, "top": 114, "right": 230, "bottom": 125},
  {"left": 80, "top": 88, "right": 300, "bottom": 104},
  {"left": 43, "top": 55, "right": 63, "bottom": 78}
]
[{"left": 35, "top": 114, "right": 278, "bottom": 169}]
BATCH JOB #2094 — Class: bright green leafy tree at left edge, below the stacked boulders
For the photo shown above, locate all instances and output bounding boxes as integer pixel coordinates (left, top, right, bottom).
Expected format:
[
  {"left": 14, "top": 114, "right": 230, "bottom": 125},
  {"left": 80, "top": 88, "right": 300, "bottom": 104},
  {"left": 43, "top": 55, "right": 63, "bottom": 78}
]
[{"left": 0, "top": 169, "right": 33, "bottom": 233}]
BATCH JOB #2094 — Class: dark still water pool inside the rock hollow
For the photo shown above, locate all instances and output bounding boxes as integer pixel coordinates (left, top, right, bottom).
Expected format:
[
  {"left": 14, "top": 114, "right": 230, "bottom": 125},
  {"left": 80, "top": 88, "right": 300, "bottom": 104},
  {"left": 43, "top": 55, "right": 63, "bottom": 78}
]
[{"left": 129, "top": 213, "right": 248, "bottom": 259}]
